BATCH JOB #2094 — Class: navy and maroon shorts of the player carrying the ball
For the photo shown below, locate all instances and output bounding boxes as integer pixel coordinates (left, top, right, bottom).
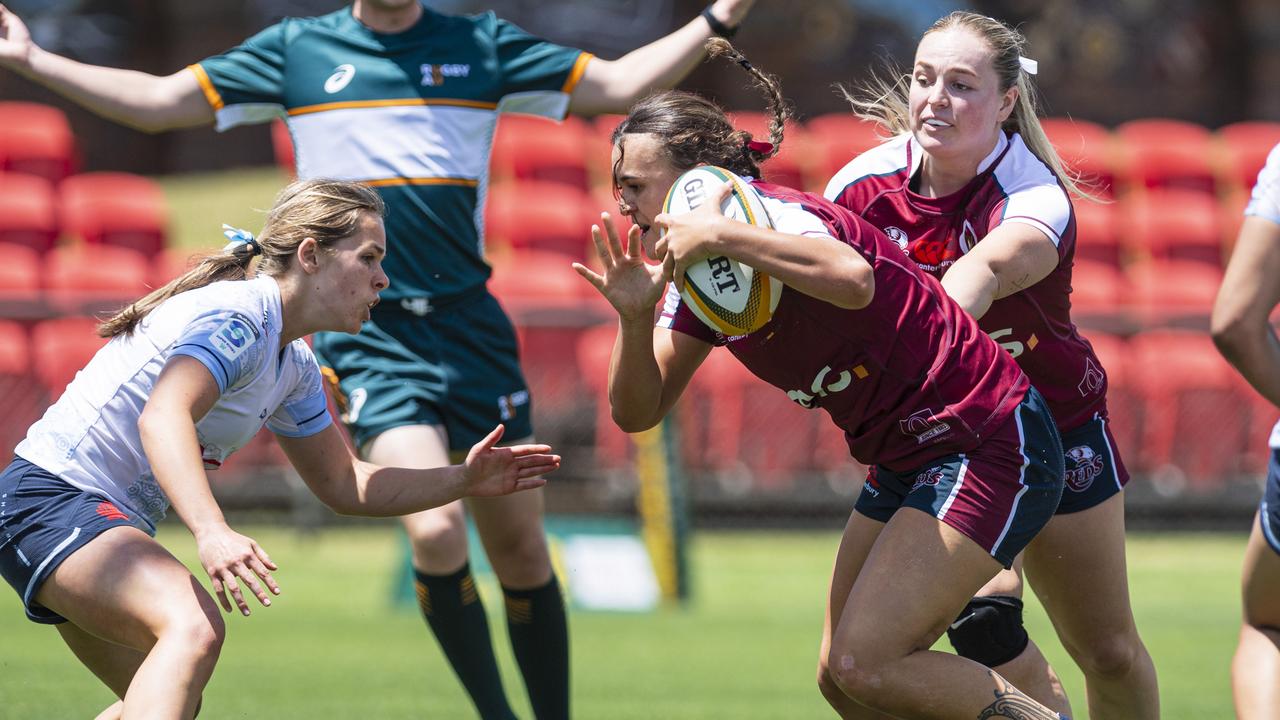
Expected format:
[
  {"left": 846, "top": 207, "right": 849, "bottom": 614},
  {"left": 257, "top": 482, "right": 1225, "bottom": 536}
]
[{"left": 854, "top": 388, "right": 1062, "bottom": 568}]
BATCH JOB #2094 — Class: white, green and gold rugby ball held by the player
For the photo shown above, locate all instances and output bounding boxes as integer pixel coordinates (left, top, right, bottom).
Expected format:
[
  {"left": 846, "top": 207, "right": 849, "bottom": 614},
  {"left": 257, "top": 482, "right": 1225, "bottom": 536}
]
[{"left": 662, "top": 165, "right": 782, "bottom": 337}]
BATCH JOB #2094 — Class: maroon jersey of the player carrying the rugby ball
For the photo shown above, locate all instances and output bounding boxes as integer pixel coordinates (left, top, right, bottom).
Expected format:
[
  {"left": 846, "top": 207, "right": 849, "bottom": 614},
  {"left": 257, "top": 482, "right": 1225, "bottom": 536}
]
[{"left": 658, "top": 182, "right": 1029, "bottom": 470}]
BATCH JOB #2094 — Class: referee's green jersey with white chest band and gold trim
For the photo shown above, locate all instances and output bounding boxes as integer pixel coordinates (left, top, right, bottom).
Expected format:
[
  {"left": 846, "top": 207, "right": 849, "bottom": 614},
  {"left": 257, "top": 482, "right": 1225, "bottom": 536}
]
[{"left": 191, "top": 8, "right": 591, "bottom": 301}]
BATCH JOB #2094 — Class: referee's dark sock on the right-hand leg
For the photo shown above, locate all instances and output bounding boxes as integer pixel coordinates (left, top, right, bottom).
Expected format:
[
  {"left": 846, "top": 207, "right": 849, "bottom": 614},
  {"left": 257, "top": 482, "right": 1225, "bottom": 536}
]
[{"left": 502, "top": 574, "right": 568, "bottom": 720}]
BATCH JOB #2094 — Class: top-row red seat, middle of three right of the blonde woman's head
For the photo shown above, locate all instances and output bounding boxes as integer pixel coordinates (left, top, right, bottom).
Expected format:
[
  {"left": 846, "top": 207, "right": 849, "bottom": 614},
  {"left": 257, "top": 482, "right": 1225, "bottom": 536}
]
[{"left": 1116, "top": 119, "right": 1216, "bottom": 193}]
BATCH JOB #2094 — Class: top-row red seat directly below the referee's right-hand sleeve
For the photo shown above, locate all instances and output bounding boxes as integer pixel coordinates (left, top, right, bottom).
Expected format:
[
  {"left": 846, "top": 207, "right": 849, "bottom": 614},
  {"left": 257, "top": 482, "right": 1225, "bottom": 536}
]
[{"left": 492, "top": 114, "right": 593, "bottom": 191}]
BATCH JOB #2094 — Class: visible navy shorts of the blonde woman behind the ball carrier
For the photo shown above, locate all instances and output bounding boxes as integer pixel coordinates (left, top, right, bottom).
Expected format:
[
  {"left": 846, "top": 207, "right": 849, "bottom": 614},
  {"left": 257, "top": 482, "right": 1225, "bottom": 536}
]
[{"left": 1057, "top": 415, "right": 1129, "bottom": 515}]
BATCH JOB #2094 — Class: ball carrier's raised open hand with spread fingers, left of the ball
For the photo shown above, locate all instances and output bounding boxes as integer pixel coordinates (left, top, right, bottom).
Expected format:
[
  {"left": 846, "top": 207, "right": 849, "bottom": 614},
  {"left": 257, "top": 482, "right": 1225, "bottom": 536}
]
[{"left": 573, "top": 213, "right": 669, "bottom": 323}]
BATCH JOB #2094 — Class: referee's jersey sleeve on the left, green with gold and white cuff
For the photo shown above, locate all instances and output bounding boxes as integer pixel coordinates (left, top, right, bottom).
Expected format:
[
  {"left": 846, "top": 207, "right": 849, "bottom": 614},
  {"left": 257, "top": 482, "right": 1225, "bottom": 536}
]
[{"left": 189, "top": 22, "right": 288, "bottom": 131}]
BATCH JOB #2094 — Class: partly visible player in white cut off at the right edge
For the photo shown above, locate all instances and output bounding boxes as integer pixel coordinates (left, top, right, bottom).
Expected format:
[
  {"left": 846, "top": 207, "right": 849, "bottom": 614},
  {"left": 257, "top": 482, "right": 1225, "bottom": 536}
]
[{"left": 1213, "top": 145, "right": 1280, "bottom": 720}]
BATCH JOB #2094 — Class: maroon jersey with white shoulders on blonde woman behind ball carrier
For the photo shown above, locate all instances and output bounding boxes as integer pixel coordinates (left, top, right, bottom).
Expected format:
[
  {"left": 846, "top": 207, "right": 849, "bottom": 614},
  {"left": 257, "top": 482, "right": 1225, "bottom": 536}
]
[{"left": 826, "top": 133, "right": 1107, "bottom": 430}]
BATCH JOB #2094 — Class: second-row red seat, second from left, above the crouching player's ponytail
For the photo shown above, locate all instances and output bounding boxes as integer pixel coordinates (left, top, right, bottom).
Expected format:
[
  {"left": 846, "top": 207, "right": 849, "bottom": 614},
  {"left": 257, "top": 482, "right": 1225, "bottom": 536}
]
[{"left": 60, "top": 173, "right": 169, "bottom": 255}]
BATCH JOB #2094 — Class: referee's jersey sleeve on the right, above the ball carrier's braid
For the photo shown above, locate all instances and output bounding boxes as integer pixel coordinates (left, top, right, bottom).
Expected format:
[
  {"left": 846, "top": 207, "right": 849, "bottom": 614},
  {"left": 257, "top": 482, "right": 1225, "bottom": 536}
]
[{"left": 490, "top": 17, "right": 593, "bottom": 120}]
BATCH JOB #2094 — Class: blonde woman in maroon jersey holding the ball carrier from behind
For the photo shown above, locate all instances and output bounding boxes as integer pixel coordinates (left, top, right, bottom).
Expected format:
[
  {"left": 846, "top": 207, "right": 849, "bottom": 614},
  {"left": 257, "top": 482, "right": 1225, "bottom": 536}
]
[{"left": 819, "top": 12, "right": 1160, "bottom": 720}]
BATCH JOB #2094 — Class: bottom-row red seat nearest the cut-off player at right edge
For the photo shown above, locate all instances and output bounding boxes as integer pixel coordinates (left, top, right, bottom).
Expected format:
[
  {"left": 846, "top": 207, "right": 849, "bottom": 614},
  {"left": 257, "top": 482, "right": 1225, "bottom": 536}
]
[{"left": 1130, "top": 331, "right": 1249, "bottom": 491}]
